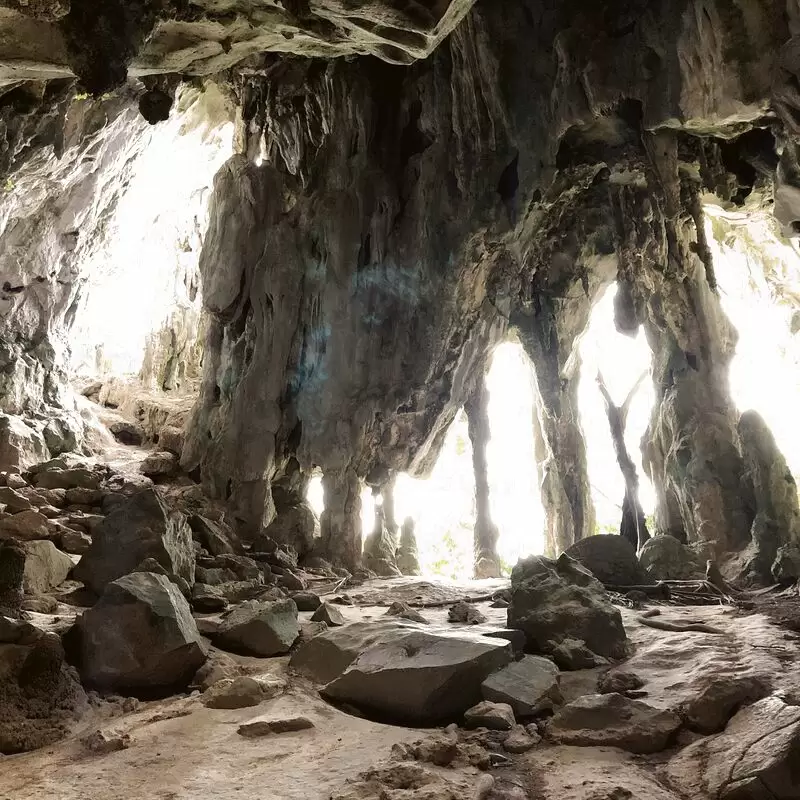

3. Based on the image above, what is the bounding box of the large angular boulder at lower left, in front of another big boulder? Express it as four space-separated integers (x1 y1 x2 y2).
78 572 206 694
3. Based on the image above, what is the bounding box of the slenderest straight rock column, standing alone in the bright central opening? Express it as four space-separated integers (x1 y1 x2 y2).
464 375 500 578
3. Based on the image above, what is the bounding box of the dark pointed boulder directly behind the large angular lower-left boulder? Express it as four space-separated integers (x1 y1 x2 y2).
75 488 195 594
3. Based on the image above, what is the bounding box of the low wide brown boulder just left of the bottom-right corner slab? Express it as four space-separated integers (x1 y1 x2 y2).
547 694 681 753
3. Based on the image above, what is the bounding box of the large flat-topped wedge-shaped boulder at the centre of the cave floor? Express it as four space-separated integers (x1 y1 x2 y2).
318 623 512 725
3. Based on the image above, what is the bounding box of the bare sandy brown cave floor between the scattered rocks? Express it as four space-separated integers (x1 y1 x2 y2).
0 579 800 800
